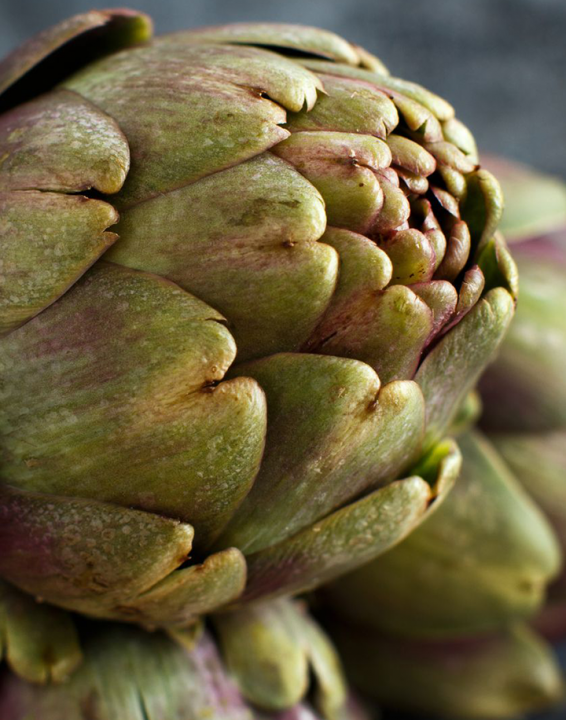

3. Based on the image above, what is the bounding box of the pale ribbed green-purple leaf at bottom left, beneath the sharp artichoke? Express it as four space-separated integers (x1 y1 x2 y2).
0 623 253 720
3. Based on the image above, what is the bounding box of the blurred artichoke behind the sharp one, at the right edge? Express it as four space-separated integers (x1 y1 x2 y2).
323 160 566 718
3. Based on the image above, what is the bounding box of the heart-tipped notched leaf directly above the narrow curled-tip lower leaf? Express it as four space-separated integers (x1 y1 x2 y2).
218 353 424 555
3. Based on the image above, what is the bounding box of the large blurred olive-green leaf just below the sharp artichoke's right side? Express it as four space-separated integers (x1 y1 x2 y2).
321 433 560 638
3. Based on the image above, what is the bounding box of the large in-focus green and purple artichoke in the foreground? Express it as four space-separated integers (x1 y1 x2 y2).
0 10 517 679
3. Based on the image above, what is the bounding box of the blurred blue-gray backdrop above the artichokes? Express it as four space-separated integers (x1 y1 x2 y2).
0 0 566 177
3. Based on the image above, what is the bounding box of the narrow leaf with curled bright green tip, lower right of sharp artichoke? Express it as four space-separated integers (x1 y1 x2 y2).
241 442 460 601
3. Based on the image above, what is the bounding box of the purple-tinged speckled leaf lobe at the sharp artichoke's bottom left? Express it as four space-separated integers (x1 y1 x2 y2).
0 485 194 617
